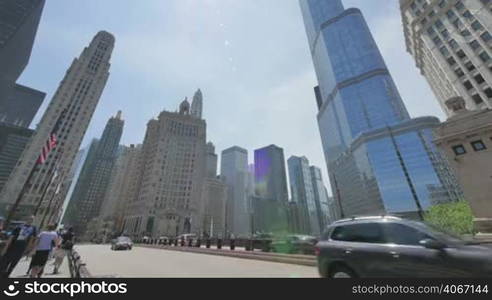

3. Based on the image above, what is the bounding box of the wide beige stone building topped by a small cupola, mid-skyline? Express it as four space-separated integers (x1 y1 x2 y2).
125 100 206 236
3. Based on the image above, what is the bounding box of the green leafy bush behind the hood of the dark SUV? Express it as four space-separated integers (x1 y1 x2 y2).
424 201 475 235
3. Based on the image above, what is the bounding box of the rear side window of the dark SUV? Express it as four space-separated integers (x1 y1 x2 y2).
331 223 384 243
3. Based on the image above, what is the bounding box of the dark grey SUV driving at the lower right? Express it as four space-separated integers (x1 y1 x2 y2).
316 217 492 278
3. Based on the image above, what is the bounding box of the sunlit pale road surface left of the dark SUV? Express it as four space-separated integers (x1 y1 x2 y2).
76 245 319 278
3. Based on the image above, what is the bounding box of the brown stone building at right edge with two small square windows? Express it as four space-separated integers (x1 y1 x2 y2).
436 97 492 233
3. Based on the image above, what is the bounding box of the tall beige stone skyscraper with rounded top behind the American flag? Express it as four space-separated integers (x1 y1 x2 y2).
0 31 115 220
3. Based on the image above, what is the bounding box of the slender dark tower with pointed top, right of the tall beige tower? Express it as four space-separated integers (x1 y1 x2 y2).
65 111 124 236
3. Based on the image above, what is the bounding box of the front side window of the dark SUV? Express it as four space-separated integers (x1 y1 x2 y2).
382 223 431 246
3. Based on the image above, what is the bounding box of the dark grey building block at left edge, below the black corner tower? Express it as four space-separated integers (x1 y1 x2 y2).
0 84 46 127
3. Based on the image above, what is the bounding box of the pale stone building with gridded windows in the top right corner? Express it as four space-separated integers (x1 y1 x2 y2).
400 0 492 116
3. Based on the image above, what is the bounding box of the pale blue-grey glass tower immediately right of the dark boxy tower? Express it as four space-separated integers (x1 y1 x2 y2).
287 156 320 235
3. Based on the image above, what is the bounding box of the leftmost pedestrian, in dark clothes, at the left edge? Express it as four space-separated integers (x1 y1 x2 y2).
0 216 37 278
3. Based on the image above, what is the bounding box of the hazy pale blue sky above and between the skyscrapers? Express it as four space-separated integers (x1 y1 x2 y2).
19 0 444 194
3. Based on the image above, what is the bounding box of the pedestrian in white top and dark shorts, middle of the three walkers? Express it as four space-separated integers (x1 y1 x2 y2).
31 224 60 278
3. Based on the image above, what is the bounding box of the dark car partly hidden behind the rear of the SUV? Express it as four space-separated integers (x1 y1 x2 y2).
271 235 318 255
